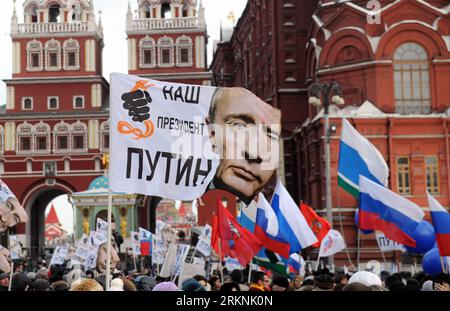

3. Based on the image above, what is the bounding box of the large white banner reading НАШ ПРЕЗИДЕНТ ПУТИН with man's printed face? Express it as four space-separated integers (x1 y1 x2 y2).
109 74 281 203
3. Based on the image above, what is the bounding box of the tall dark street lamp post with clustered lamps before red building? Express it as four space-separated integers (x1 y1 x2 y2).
309 82 345 266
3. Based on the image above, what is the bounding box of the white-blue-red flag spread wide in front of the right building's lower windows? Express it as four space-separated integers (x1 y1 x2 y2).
359 176 424 247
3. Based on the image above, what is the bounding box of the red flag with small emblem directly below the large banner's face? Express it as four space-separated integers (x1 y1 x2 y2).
211 200 261 266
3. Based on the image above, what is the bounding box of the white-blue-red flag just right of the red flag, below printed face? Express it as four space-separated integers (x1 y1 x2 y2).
255 193 290 258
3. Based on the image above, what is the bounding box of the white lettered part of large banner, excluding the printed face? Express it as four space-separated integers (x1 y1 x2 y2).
109 74 219 200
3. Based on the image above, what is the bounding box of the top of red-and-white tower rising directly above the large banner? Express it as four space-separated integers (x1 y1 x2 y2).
126 0 211 85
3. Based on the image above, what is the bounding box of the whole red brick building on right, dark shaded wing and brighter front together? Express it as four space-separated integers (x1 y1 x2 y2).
212 0 450 264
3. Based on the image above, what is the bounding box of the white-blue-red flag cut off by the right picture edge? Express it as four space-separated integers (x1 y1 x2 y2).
427 192 450 257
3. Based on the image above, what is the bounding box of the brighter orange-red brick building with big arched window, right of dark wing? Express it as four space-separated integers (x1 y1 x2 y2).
295 0 450 268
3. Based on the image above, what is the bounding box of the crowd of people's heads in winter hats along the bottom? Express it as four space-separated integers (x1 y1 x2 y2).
0 261 450 292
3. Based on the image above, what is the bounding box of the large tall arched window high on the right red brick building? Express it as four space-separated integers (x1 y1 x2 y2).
394 42 431 114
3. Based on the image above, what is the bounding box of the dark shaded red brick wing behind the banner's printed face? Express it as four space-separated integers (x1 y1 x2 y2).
211 0 317 197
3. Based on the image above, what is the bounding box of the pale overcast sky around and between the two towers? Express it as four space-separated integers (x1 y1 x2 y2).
0 0 247 105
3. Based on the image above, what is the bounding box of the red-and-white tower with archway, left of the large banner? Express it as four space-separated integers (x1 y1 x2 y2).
0 0 109 254
